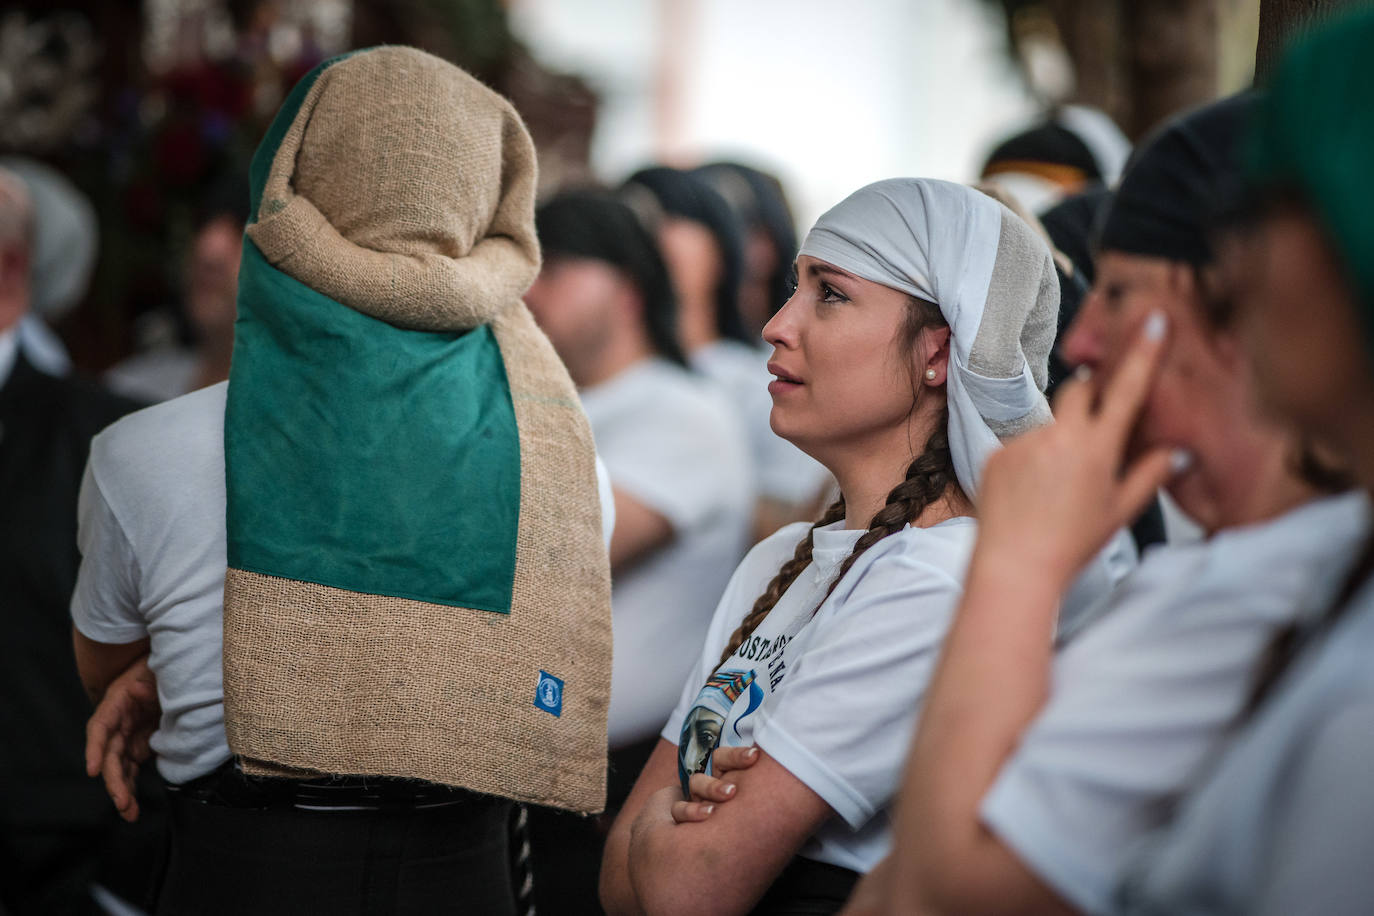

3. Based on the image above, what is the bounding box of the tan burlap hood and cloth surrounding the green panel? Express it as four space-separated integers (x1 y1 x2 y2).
224 48 611 812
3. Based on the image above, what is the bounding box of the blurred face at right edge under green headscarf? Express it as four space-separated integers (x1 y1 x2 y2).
1223 207 1374 466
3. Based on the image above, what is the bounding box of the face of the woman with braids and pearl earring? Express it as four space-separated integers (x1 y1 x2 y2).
764 255 949 464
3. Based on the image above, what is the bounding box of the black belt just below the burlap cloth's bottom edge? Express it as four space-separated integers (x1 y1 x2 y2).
166 758 503 812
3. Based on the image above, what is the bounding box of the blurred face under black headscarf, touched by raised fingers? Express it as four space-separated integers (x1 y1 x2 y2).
1061 251 1257 530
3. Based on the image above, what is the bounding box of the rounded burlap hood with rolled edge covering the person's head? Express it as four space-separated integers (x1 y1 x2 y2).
247 47 539 331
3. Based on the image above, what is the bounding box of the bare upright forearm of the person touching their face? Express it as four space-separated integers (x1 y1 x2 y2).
892 549 1063 912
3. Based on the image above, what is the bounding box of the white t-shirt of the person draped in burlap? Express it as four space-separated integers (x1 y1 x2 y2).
71 382 616 783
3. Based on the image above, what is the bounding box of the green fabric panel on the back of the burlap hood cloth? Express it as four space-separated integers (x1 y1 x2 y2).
224 240 521 614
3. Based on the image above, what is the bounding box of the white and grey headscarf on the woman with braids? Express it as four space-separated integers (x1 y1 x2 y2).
800 179 1059 499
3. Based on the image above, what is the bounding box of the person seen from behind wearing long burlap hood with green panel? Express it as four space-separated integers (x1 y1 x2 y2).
73 48 610 913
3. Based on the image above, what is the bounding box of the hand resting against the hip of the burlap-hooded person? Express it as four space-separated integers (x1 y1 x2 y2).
85 655 162 821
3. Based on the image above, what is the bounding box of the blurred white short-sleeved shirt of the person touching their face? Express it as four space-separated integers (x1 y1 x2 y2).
981 494 1369 913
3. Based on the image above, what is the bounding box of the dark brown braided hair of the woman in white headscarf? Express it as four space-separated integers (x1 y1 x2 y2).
717 297 958 665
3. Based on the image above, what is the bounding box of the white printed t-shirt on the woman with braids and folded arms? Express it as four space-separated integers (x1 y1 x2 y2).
662 518 978 873
